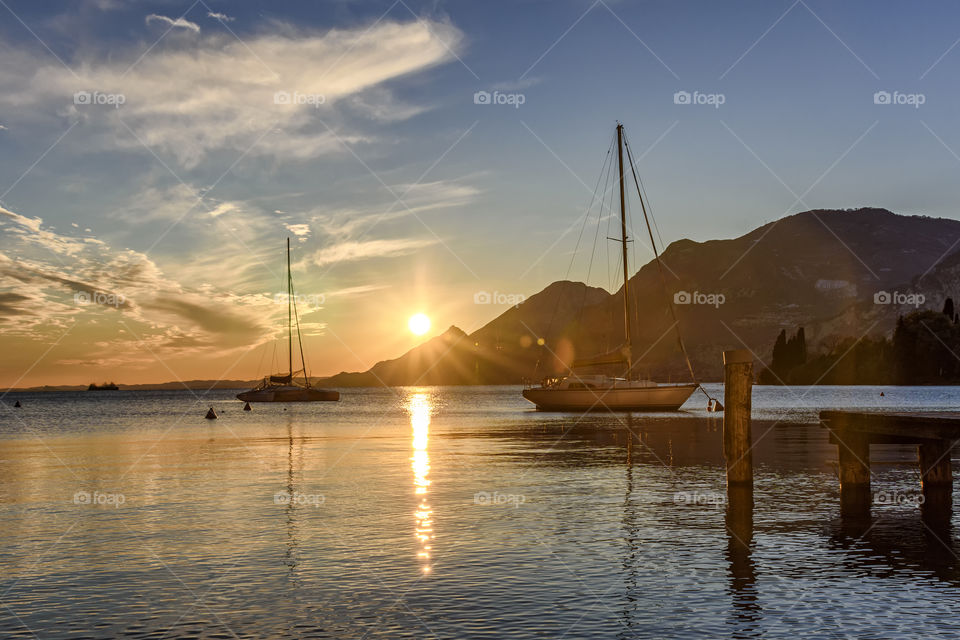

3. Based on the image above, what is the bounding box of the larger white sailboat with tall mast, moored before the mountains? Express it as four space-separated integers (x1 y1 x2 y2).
523 122 700 411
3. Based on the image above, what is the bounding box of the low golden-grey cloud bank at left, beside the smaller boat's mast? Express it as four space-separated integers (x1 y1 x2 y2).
0 202 280 353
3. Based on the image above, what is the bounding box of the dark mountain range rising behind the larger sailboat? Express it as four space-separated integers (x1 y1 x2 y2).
325 208 960 386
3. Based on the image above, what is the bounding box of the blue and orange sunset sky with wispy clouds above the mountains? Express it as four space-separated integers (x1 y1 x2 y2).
0 0 960 388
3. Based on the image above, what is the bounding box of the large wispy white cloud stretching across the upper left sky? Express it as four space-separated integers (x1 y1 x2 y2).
0 16 462 168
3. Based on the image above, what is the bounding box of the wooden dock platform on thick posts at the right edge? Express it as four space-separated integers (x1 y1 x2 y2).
820 411 960 504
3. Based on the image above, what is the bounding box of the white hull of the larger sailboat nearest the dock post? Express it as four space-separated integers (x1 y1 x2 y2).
523 384 697 411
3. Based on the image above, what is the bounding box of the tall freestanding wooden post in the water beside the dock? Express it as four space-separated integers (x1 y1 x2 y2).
723 349 753 485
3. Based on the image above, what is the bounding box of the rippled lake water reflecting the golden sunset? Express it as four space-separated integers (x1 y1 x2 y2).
0 385 960 639
